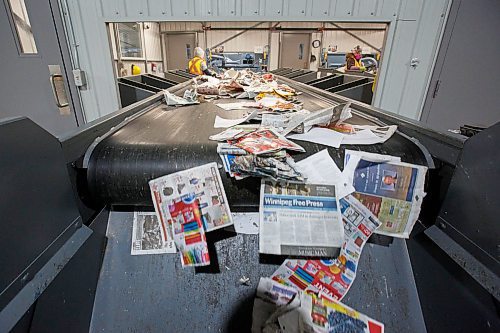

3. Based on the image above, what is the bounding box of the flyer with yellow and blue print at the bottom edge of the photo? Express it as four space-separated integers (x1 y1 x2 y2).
298 293 384 333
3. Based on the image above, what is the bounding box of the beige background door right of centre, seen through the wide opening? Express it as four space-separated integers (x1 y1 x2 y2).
280 32 311 69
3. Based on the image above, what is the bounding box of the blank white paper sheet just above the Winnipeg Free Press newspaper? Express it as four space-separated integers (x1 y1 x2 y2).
295 149 354 199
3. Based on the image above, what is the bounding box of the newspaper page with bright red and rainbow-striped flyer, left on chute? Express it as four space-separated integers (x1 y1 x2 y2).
149 163 232 266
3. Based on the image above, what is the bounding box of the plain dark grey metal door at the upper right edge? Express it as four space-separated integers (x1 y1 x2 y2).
421 0 500 131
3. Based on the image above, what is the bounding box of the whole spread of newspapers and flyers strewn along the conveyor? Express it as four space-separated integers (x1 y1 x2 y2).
136 70 427 333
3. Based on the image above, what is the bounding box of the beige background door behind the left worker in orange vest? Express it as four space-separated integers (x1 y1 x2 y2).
164 33 196 69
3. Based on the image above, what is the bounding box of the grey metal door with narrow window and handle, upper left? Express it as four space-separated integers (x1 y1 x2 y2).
0 0 83 136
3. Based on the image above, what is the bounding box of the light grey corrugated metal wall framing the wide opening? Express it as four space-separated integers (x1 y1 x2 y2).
60 0 451 120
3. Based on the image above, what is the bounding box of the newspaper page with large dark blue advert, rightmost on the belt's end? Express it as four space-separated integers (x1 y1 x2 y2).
344 154 427 238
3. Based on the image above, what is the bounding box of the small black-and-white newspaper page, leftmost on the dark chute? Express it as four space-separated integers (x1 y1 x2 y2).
131 212 176 255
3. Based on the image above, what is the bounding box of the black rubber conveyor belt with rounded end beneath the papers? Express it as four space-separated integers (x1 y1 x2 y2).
87 79 426 211
